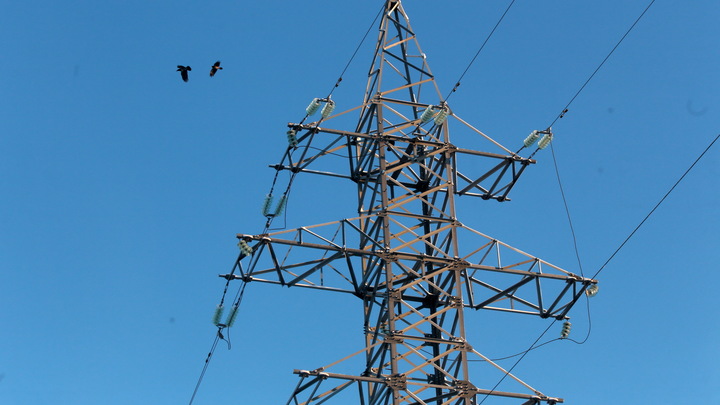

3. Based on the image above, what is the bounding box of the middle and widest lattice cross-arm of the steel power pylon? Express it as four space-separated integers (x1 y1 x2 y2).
235 216 596 319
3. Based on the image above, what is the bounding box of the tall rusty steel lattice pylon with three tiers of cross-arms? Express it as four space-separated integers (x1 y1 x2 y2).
221 0 596 405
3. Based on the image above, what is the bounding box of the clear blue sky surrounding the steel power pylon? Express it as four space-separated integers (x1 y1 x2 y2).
0 0 720 405
